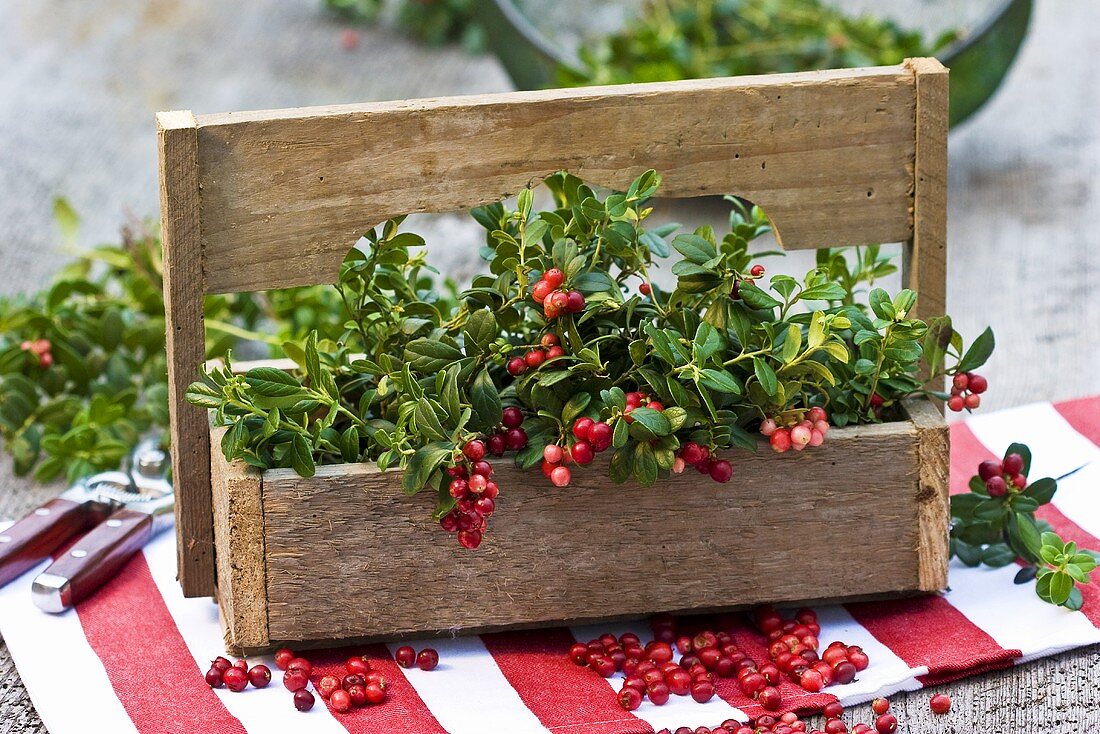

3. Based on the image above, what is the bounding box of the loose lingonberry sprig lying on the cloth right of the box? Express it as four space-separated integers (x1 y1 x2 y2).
950 443 1100 610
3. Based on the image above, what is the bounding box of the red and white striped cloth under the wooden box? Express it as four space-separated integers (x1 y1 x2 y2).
0 397 1100 734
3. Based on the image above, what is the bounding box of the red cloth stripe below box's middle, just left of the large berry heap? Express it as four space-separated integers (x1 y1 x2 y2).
481 627 653 734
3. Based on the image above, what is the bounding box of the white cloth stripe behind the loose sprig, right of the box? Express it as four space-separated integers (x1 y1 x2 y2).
967 403 1100 480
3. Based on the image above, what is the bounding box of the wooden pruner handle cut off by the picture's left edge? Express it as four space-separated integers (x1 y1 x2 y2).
0 497 91 587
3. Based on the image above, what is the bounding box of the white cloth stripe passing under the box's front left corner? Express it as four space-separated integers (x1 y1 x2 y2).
144 530 348 734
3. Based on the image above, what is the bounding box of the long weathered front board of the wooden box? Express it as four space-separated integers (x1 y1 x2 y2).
249 398 946 640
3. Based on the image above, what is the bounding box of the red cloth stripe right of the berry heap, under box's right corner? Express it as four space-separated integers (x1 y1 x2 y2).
845 596 1021 676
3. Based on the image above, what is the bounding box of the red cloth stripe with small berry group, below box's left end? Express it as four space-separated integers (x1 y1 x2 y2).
303 644 447 734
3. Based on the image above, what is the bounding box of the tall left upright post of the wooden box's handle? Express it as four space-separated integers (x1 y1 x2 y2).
156 112 215 596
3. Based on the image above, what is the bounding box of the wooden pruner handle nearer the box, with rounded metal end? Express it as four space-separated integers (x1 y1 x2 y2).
31 510 153 613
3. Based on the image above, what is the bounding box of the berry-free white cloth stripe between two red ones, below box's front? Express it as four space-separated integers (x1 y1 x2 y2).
388 635 550 734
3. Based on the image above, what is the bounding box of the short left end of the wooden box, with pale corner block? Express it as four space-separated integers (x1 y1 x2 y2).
210 428 268 655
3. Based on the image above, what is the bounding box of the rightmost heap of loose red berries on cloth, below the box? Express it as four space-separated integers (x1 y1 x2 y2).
756 606 870 695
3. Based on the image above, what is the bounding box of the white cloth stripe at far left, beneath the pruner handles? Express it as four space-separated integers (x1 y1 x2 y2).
0 523 138 734
